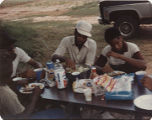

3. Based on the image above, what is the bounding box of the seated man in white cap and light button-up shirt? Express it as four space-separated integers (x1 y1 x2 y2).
52 21 97 68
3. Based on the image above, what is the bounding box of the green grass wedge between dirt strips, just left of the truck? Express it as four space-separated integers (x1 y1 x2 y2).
63 1 99 17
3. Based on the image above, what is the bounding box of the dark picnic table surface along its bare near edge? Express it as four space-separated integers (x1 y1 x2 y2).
41 79 152 118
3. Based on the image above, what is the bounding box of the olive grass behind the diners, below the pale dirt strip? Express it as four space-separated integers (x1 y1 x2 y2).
0 21 109 63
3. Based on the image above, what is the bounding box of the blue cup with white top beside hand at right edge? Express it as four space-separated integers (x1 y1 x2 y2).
135 71 146 86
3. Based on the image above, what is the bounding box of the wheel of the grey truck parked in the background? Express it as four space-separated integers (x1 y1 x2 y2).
114 16 138 38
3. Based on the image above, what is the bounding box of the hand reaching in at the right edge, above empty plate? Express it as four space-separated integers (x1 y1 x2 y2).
141 76 152 90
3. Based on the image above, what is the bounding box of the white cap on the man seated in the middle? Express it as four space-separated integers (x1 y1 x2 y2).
76 21 92 37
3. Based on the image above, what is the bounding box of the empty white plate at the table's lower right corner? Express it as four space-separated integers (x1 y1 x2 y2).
134 95 152 110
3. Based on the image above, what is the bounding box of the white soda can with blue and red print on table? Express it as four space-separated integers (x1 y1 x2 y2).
54 69 67 89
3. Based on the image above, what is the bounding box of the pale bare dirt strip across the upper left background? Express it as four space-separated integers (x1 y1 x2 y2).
0 0 98 24
